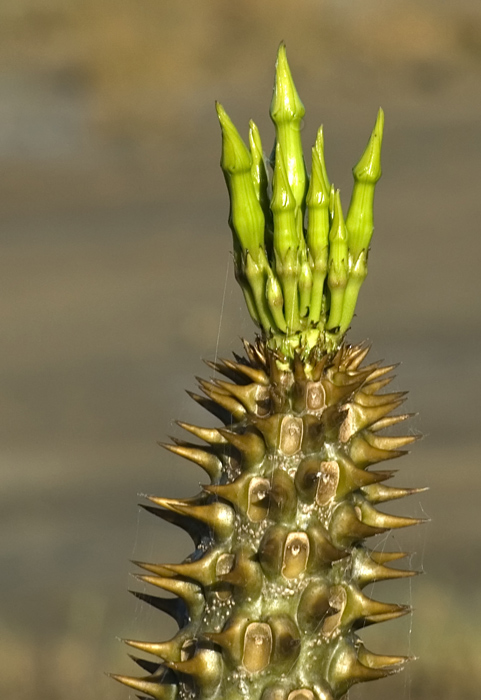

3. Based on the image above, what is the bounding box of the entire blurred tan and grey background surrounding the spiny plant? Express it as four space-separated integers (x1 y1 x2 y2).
0 0 481 700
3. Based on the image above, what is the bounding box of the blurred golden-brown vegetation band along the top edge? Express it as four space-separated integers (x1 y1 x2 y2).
0 0 481 148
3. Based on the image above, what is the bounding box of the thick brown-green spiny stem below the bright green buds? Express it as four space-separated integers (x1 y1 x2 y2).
117 340 419 700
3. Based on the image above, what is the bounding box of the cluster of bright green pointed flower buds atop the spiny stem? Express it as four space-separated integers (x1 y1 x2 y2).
217 44 384 355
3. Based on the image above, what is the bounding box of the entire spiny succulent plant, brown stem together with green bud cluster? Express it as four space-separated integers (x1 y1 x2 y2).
115 39 420 700
